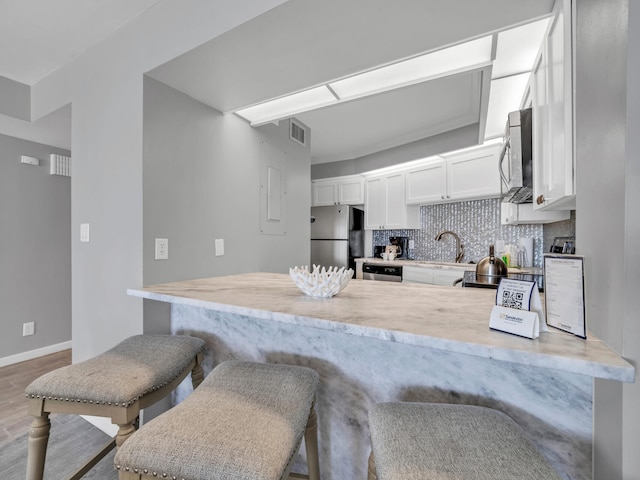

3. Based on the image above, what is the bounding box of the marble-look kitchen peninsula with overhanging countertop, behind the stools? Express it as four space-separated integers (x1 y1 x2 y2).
128 273 635 480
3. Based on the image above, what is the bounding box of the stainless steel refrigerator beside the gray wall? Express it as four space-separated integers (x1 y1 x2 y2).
310 205 364 271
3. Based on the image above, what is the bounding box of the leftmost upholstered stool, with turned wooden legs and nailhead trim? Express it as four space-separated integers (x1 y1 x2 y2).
26 335 205 480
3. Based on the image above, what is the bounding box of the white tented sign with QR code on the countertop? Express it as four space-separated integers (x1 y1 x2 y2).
489 278 548 339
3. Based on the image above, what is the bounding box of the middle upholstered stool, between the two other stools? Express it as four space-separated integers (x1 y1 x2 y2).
115 361 320 480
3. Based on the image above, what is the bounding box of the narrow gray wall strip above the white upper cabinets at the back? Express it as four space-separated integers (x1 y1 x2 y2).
311 124 478 180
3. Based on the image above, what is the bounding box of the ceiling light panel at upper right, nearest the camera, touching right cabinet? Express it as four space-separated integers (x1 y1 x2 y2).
491 18 550 78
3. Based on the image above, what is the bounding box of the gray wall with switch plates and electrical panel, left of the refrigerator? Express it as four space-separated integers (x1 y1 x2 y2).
143 78 311 285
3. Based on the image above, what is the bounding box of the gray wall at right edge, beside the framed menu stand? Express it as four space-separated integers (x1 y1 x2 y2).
575 0 640 480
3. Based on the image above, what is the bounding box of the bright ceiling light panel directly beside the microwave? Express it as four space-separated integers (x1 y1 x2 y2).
484 72 531 140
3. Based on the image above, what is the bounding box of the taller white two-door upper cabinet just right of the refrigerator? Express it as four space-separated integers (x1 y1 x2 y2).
364 171 420 230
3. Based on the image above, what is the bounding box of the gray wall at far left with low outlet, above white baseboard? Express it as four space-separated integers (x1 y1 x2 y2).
0 135 71 359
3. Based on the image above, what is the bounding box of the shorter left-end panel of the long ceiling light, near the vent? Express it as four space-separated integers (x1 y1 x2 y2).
235 85 337 126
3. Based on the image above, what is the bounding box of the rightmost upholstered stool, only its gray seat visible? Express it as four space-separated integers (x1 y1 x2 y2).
369 403 560 480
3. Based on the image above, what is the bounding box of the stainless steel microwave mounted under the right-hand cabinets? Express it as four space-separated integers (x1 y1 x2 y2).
498 108 533 203
